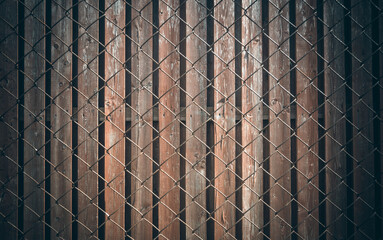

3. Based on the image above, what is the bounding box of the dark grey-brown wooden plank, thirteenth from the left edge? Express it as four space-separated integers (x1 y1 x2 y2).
323 0 347 239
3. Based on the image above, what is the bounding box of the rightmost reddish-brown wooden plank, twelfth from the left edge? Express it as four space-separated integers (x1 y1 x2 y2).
295 0 319 239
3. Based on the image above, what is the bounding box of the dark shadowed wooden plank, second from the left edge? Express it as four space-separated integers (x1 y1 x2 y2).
24 0 45 239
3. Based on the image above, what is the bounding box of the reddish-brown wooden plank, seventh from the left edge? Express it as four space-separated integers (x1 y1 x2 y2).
158 0 180 239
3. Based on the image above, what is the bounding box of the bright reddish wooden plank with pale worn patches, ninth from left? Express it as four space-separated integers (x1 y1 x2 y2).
214 0 236 239
